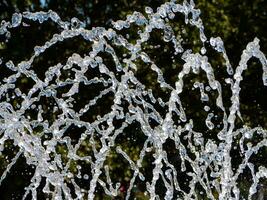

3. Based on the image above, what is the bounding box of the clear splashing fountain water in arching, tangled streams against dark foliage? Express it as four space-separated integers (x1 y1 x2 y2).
0 0 267 200
